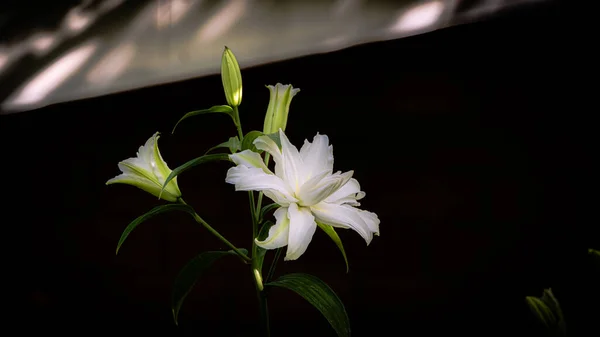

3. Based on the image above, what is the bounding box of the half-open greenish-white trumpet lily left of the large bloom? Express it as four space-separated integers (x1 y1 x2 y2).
106 132 181 202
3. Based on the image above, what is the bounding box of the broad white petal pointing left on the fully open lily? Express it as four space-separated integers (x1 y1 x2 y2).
225 165 298 206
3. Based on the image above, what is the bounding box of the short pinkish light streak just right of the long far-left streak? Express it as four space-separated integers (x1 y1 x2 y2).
86 43 137 85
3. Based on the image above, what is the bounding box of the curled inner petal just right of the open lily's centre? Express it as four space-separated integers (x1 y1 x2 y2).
296 171 354 206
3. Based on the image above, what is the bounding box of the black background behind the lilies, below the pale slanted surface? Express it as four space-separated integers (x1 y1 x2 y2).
0 4 599 336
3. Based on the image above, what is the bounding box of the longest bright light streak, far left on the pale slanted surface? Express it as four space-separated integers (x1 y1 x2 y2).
7 43 98 105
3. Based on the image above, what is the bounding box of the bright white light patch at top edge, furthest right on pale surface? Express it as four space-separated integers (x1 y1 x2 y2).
390 1 444 33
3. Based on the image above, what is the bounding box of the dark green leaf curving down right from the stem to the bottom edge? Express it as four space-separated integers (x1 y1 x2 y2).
265 273 350 337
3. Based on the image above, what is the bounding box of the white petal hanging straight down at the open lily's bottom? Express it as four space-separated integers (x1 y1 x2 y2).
284 204 317 261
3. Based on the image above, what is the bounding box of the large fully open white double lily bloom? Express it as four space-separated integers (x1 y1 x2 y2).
225 129 379 261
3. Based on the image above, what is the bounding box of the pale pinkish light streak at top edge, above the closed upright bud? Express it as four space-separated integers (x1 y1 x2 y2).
196 0 248 42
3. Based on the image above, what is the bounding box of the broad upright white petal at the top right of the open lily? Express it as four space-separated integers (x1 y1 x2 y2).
300 133 333 182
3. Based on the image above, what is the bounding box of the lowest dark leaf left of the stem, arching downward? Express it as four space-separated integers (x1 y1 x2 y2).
171 249 248 324
